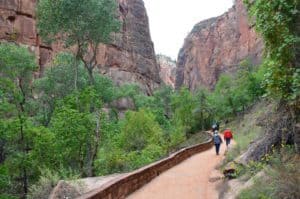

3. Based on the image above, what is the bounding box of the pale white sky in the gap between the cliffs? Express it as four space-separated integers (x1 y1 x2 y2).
144 0 233 60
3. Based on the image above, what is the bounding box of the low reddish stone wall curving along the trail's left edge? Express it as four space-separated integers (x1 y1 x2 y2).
78 139 213 199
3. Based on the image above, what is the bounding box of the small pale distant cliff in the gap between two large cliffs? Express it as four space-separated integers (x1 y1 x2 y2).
156 55 176 88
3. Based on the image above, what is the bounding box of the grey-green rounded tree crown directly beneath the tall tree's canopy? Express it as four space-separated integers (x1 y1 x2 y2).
34 53 88 126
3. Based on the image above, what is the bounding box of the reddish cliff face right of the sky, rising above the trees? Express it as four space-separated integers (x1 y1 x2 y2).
176 0 263 90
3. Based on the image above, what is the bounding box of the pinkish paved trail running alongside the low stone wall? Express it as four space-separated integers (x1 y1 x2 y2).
127 138 230 199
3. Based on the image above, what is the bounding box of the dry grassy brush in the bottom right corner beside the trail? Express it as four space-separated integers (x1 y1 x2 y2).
238 146 300 199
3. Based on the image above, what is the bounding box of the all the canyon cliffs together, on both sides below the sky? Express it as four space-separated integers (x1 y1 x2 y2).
0 0 263 91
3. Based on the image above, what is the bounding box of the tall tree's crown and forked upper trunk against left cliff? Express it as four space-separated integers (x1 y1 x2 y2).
37 0 120 84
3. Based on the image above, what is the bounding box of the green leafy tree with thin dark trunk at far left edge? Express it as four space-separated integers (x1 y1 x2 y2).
0 43 37 198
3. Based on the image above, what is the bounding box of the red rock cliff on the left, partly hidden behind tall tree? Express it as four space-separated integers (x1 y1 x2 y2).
0 0 160 93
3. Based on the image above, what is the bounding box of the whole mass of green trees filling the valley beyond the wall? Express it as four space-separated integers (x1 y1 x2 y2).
0 43 263 198
